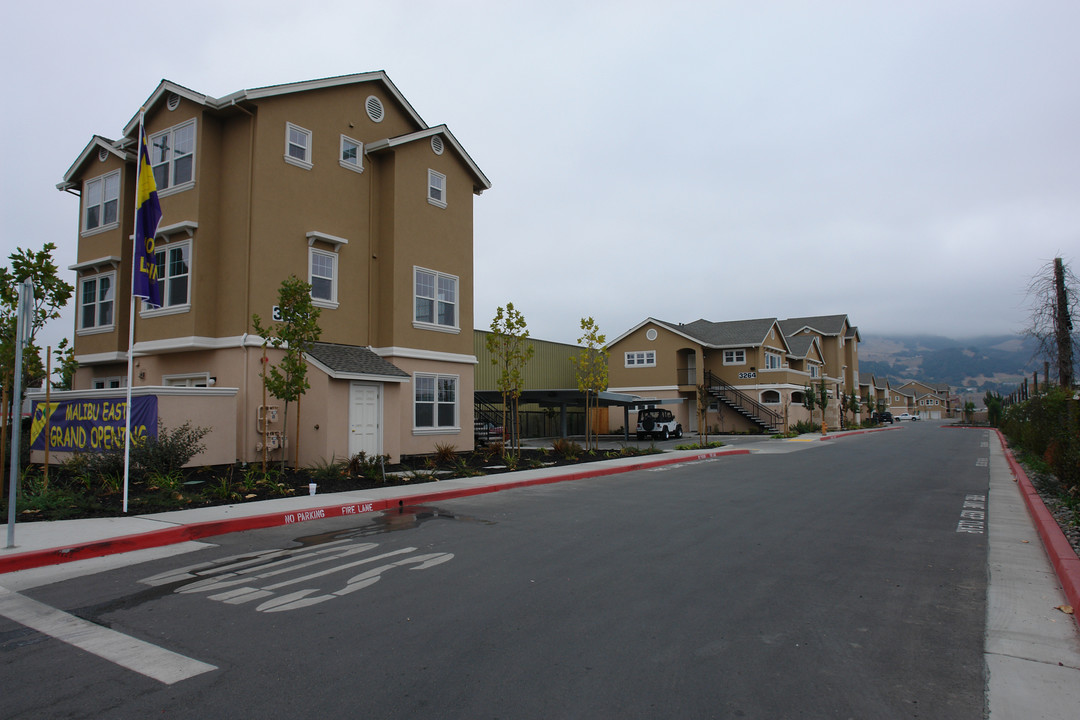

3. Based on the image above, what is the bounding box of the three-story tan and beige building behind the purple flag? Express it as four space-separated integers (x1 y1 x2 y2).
57 72 491 465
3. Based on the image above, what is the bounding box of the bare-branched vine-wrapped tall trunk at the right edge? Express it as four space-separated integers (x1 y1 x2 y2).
1027 258 1080 388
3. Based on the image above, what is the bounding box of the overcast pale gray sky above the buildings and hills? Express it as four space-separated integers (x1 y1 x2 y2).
0 0 1080 342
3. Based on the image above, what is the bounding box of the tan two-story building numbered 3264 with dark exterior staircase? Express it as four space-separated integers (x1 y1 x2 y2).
608 314 860 432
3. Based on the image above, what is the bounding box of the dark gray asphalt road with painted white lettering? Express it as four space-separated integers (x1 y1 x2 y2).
0 422 988 719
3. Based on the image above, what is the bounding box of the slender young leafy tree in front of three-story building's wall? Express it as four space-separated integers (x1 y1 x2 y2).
252 275 323 472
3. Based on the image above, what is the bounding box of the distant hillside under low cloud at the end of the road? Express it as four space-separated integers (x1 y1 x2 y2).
859 335 1042 397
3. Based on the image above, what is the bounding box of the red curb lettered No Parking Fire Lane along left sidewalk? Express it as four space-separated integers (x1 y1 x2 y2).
0 450 750 574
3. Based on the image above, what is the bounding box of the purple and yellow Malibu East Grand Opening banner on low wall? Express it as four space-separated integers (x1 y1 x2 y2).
30 395 158 452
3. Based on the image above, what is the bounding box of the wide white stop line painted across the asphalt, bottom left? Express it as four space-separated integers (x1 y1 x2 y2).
0 587 217 685
